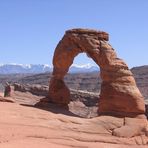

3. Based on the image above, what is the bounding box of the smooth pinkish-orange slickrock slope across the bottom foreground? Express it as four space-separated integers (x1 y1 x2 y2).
0 102 148 148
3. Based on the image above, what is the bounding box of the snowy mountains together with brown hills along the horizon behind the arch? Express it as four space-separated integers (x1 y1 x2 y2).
0 64 148 100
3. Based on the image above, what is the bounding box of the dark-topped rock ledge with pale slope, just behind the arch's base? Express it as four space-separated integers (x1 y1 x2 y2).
0 83 148 118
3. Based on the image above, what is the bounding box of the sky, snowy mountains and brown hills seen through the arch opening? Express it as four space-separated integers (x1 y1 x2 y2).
64 53 101 93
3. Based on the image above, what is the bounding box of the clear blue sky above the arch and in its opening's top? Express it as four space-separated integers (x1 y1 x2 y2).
0 0 148 67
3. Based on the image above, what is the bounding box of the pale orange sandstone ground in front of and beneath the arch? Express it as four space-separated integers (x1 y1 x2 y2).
0 86 148 148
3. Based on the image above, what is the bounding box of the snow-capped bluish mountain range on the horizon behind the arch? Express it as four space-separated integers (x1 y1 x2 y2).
0 63 99 74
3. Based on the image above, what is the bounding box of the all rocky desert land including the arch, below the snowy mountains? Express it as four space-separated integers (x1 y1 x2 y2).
0 29 148 148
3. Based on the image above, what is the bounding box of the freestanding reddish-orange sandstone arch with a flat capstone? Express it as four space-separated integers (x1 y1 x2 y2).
49 29 145 117
